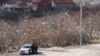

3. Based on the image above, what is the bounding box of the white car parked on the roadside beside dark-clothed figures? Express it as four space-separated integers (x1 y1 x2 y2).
19 44 33 55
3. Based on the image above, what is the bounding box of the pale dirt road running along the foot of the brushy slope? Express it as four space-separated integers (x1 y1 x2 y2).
0 44 100 56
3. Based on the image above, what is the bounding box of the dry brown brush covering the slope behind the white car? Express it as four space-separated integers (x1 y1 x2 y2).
0 9 100 52
